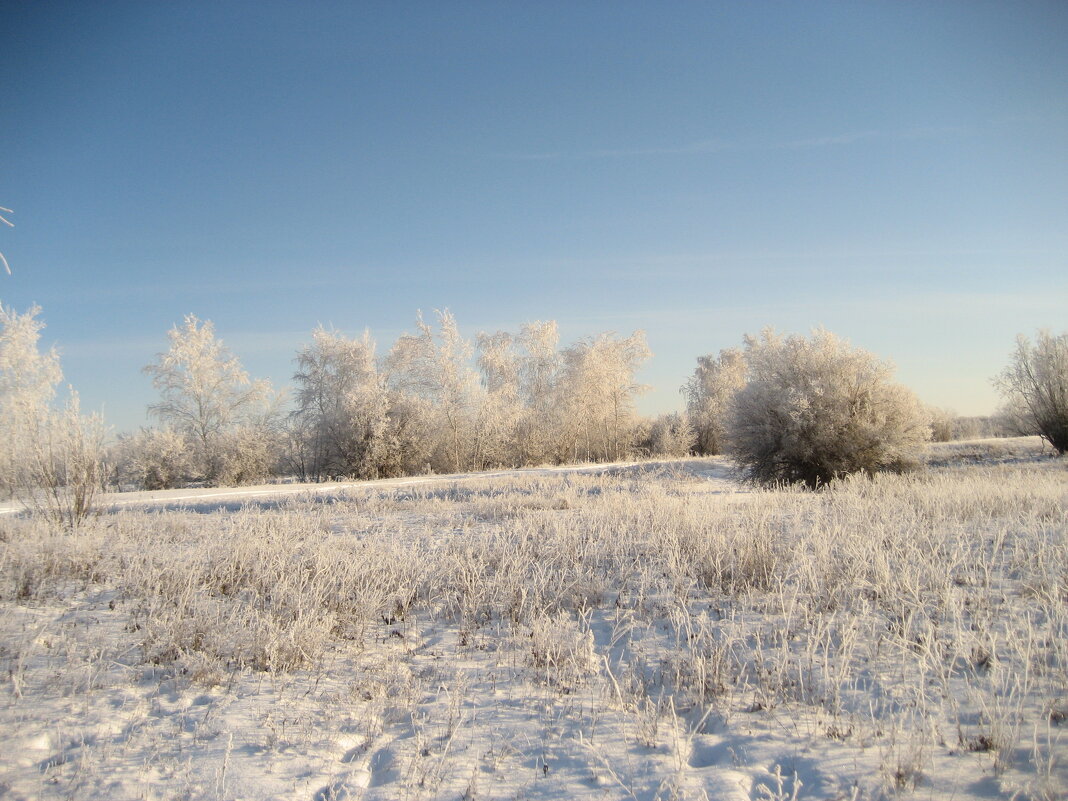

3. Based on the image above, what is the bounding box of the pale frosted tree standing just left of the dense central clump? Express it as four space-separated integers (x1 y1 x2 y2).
144 314 279 485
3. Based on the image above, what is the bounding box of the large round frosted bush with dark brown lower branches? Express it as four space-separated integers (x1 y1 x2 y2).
727 329 930 487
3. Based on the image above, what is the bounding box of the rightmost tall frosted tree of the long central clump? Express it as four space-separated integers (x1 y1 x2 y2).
557 331 650 461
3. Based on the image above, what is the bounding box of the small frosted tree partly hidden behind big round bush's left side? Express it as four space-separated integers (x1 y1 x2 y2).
682 348 745 456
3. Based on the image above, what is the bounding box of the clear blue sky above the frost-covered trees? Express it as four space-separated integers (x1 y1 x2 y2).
0 0 1068 429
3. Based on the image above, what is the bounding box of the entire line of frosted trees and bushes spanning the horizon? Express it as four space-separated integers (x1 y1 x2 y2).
0 294 1068 524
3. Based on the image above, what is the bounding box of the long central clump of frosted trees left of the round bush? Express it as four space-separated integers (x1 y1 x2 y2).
120 311 649 487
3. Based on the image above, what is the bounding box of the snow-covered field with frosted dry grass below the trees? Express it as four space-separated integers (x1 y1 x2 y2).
0 441 1068 801
